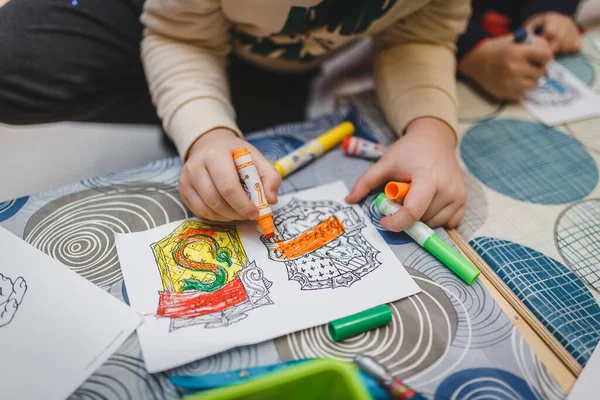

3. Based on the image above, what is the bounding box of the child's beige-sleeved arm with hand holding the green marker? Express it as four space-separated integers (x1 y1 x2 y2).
348 0 470 231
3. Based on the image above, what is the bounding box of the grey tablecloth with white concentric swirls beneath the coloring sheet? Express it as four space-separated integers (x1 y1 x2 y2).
0 108 564 399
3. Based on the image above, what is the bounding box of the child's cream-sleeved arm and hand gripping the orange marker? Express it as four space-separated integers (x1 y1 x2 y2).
141 0 281 221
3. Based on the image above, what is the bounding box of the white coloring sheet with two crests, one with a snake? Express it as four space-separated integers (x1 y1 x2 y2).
116 182 421 372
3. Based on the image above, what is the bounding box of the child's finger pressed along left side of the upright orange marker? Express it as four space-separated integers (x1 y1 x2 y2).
206 156 258 219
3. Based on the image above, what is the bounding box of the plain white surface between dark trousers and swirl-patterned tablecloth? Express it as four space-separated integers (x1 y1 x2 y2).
0 122 175 202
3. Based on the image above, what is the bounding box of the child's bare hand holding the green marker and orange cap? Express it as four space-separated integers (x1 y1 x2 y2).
346 118 467 232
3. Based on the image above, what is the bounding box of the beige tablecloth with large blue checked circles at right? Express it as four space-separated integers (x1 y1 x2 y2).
350 43 600 372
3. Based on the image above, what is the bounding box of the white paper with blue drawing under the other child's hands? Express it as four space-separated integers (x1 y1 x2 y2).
523 61 600 126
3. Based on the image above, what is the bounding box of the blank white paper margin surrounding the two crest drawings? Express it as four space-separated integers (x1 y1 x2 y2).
115 182 421 373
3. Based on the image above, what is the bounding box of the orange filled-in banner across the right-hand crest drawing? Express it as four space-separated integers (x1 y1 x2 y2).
274 216 345 260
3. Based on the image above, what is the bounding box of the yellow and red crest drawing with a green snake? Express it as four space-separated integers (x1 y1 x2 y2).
151 220 272 330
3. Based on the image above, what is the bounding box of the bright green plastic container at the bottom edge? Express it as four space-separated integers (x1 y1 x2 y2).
183 360 372 400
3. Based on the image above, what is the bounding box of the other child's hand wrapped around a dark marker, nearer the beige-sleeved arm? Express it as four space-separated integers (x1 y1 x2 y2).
458 35 552 100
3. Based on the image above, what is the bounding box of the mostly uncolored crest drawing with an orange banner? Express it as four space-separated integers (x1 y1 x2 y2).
261 198 381 290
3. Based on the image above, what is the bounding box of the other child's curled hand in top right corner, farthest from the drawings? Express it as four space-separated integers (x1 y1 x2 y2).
523 12 581 54
